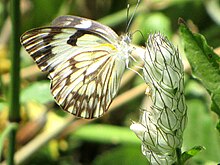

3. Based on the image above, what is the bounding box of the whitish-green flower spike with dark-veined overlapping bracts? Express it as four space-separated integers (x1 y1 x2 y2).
130 33 187 165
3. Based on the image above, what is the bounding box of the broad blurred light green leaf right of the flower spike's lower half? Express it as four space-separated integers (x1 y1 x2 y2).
182 98 220 164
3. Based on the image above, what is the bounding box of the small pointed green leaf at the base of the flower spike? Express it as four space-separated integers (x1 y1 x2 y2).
181 146 205 164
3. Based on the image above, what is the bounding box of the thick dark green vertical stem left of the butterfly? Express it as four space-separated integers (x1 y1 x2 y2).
7 0 20 165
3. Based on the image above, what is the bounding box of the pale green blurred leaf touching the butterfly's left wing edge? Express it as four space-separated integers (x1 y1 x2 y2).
21 81 54 104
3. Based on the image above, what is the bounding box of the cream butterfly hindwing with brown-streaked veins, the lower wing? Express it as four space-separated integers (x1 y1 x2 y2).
51 49 123 118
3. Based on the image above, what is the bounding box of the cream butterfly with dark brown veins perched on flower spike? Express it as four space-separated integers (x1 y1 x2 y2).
20 15 133 119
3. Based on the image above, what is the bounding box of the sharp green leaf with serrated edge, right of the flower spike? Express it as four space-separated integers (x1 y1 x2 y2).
180 24 220 115
